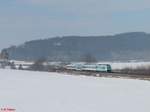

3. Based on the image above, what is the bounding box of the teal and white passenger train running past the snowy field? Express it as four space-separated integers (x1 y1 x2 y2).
66 63 112 72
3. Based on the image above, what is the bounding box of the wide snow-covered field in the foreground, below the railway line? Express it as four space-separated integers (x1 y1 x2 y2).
0 69 150 112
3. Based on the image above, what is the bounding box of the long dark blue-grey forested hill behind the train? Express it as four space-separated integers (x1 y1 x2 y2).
3 32 150 61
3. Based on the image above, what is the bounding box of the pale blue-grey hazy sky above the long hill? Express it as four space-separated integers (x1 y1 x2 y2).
0 0 150 49
